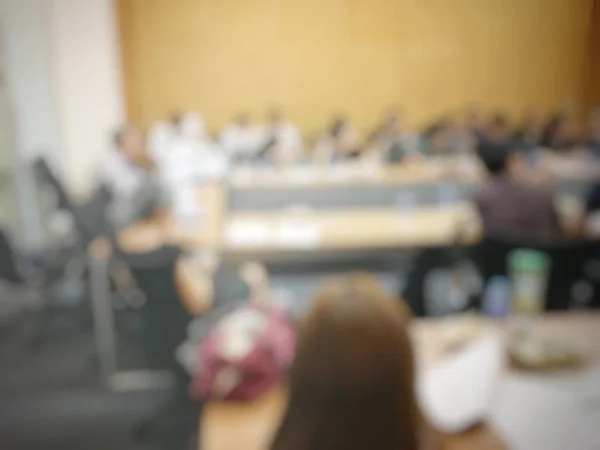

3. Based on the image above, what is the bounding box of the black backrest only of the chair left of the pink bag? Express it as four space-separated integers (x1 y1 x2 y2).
119 247 191 370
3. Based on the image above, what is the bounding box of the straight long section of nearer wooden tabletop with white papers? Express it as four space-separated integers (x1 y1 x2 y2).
223 204 480 253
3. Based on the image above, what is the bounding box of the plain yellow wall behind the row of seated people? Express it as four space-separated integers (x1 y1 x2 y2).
118 0 592 134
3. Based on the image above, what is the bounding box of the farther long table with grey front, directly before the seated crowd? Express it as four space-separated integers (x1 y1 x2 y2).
227 155 600 212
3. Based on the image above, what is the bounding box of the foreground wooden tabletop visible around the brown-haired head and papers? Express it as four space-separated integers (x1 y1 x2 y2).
200 313 600 450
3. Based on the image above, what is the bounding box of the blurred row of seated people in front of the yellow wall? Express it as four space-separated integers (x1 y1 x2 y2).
106 103 600 185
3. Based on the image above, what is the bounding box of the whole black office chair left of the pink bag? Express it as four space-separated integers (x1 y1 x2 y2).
118 247 200 450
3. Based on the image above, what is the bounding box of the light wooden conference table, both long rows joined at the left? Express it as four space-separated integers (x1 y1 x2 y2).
121 155 600 257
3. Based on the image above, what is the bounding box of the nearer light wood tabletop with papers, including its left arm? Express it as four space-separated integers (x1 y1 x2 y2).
119 195 579 259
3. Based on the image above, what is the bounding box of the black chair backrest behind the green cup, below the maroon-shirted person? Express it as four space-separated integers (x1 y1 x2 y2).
473 235 594 310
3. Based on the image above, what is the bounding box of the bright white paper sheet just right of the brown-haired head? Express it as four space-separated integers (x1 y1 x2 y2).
418 332 505 433
